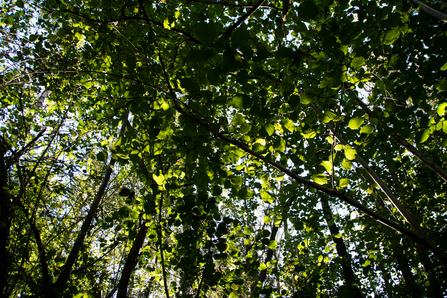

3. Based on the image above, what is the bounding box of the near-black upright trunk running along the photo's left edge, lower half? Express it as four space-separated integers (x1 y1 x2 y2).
0 143 11 296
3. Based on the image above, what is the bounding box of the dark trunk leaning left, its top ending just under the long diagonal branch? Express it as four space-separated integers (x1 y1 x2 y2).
320 196 363 298
